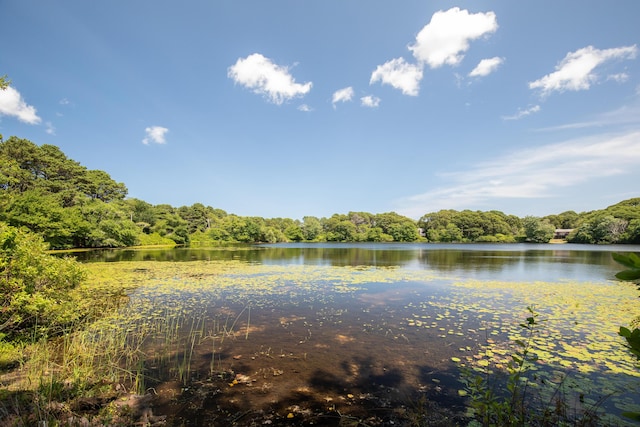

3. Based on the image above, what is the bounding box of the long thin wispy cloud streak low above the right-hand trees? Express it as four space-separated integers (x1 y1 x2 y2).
398 131 640 218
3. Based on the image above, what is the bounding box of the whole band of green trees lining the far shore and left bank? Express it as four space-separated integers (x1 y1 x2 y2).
0 135 640 249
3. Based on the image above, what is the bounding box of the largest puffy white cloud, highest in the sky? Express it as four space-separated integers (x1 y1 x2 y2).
409 7 498 68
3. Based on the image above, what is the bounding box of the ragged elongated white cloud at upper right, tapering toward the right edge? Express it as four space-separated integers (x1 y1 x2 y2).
529 45 638 96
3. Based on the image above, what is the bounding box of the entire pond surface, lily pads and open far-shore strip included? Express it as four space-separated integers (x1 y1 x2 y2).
71 244 640 425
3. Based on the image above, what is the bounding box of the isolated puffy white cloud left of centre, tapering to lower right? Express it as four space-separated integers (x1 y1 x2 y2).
227 53 313 105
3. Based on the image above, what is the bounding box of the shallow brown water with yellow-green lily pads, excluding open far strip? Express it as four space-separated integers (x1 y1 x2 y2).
82 261 640 425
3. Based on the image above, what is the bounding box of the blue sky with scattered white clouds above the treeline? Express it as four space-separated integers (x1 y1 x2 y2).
0 0 640 219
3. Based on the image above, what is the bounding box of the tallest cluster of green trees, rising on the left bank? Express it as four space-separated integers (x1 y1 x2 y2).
0 137 134 248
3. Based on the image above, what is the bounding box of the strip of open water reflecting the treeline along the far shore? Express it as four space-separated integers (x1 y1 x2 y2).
61 243 640 280
